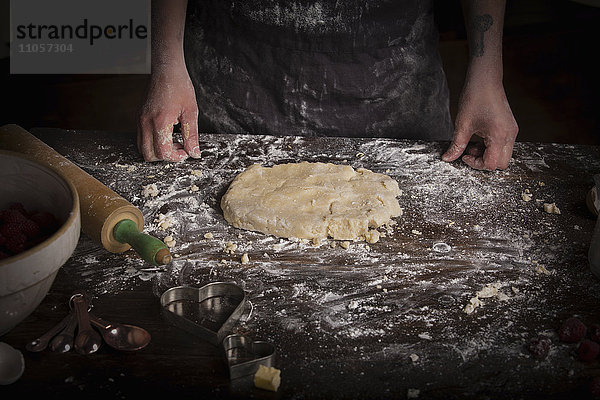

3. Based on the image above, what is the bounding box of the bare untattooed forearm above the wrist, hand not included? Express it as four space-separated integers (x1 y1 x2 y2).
152 0 187 69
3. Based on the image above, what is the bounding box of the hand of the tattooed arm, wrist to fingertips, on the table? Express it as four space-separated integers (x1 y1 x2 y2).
442 81 519 171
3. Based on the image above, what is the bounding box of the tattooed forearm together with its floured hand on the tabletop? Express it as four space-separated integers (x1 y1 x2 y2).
442 0 519 171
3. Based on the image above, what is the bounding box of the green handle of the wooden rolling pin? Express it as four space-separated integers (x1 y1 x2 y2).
113 219 172 266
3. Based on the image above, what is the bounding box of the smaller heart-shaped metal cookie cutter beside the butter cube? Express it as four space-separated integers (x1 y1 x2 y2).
223 334 275 379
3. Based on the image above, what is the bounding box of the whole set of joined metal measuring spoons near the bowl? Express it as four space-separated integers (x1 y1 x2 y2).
25 292 150 354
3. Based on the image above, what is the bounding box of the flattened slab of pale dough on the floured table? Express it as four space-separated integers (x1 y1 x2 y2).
221 162 402 242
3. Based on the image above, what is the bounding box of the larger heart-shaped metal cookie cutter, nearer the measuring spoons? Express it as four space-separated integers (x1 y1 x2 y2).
160 282 246 346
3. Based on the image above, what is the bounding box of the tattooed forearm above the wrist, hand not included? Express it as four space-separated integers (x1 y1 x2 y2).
462 0 506 86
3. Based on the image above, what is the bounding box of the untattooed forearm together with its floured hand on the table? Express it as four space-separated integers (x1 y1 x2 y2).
137 0 200 161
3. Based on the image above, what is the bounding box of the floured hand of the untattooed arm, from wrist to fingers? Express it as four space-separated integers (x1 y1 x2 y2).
137 64 200 161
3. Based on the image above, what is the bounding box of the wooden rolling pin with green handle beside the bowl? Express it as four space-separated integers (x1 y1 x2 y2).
0 125 171 265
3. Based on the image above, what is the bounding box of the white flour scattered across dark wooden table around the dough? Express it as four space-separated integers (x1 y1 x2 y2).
58 135 600 396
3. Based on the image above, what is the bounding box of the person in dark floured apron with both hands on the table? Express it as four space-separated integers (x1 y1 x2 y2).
138 0 518 170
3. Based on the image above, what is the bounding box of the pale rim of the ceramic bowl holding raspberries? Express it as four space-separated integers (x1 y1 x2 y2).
0 150 79 268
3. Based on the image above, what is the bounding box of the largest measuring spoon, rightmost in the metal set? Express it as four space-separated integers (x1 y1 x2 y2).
90 314 150 351
